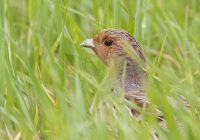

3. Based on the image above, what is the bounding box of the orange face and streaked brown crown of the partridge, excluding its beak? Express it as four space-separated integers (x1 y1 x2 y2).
93 29 145 64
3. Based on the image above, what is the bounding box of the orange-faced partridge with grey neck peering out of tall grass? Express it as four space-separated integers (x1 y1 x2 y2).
80 28 147 115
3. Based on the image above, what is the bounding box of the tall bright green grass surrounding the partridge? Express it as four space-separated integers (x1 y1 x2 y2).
0 0 200 140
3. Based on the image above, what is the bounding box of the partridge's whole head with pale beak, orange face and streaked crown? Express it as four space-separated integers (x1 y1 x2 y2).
80 29 145 65
